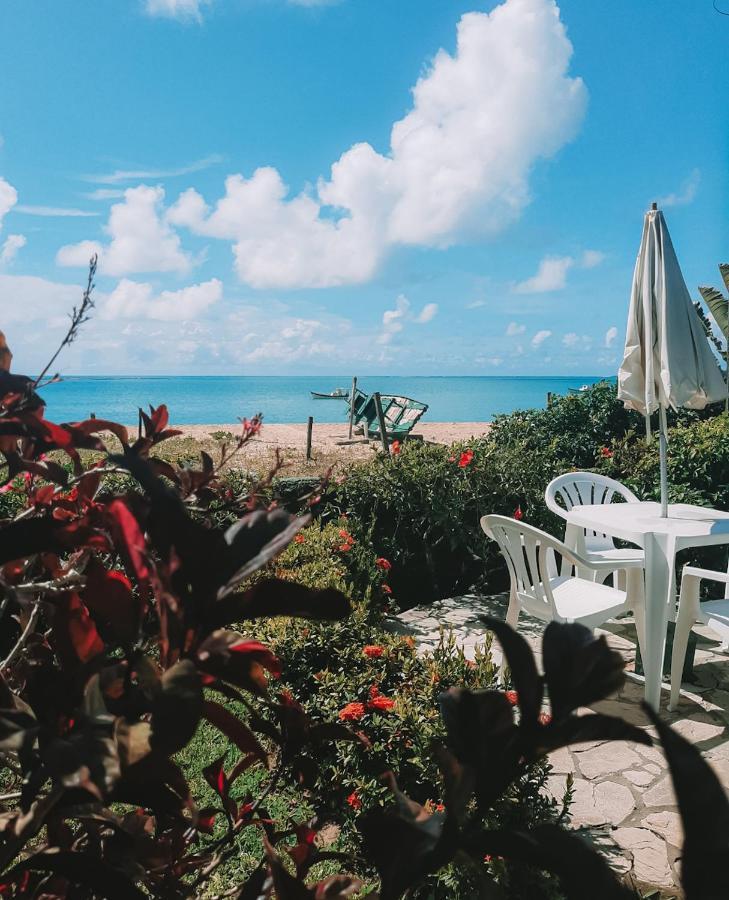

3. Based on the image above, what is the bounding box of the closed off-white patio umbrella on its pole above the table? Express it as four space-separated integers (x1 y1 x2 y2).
618 203 726 517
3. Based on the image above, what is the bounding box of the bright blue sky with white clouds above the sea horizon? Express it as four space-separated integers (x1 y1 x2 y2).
0 0 729 375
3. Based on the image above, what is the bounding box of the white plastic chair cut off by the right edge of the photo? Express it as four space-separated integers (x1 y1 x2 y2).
668 566 729 709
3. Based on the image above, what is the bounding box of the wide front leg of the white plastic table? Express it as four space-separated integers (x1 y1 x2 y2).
643 534 676 711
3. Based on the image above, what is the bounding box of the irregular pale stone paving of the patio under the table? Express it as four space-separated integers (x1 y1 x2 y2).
391 594 729 896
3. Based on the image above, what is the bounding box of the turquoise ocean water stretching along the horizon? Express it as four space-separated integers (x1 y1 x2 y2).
38 375 600 425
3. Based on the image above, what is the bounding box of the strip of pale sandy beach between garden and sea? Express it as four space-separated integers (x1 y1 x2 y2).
163 422 491 474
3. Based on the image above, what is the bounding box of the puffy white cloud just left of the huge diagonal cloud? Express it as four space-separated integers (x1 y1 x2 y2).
56 185 192 275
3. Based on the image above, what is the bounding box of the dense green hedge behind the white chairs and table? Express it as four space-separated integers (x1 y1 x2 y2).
325 382 729 607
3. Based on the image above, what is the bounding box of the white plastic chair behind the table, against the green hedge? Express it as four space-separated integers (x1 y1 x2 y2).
544 472 645 587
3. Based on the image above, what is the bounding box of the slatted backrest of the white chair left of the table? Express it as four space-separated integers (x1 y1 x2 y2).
481 515 569 617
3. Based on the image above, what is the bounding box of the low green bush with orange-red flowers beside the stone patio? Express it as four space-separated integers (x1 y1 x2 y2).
230 519 563 900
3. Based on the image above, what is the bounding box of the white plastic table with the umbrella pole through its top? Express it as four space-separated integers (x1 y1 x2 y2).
565 502 729 710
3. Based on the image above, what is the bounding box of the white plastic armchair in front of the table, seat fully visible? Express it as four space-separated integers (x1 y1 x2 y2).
481 515 645 672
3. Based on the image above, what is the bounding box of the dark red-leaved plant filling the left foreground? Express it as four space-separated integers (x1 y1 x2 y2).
0 322 360 898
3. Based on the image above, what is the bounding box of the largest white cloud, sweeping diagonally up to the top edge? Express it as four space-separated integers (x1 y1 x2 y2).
169 0 587 288
